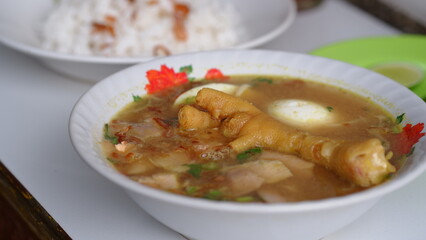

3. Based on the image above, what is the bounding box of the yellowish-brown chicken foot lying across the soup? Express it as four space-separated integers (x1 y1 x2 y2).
179 88 395 187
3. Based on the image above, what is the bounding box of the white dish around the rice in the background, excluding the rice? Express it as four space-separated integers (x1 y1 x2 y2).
0 0 296 81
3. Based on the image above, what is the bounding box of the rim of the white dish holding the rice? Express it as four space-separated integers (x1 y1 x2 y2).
0 0 297 64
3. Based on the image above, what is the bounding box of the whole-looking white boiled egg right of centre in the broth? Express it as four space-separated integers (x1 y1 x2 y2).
268 99 333 128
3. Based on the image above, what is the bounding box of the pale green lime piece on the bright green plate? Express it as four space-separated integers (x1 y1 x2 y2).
370 63 423 87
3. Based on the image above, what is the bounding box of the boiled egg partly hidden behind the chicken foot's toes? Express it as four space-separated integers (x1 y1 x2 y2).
174 83 238 106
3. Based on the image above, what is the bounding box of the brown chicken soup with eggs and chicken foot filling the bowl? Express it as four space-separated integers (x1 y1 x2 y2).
101 66 424 203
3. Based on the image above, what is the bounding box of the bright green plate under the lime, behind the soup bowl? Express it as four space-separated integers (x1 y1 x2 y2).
310 34 426 99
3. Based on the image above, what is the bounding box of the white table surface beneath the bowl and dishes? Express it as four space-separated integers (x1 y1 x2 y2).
0 0 426 240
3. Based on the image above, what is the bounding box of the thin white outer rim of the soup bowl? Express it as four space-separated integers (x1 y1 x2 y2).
68 50 426 214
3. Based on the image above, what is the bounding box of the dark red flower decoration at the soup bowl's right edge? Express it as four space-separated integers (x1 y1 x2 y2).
393 123 425 154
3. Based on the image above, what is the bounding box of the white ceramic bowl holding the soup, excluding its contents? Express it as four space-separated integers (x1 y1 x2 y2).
69 50 426 240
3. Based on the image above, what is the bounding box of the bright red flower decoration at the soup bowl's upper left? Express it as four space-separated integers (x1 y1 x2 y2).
145 65 188 94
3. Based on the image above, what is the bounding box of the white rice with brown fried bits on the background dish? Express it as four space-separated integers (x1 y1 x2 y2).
41 0 240 57
